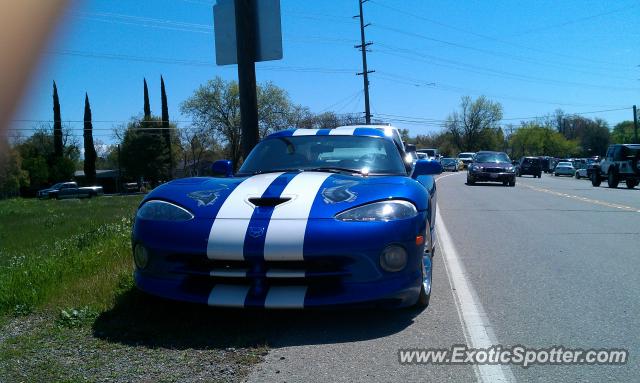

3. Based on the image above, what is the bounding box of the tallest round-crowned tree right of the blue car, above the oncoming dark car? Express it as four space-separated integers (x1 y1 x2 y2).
445 96 502 151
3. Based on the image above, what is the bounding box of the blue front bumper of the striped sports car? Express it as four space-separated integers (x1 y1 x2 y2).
133 216 427 309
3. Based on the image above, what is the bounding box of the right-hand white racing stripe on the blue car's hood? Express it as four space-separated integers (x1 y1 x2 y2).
264 173 331 261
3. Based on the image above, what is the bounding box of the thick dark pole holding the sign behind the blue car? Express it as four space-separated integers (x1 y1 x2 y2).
234 0 259 159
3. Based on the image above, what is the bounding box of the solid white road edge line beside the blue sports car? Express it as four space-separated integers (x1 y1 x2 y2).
436 208 515 382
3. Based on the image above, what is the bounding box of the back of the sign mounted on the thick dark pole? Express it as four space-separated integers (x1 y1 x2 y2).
213 0 282 65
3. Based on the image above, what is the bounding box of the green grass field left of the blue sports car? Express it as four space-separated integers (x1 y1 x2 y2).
0 196 141 316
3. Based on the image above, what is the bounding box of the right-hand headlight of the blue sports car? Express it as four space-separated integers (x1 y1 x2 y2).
336 200 418 222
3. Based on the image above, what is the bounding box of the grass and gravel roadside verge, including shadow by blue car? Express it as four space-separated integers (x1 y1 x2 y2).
0 196 266 382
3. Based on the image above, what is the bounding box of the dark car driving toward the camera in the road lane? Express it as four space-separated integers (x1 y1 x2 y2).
467 151 516 186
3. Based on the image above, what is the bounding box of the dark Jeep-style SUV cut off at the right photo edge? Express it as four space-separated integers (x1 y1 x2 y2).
587 144 640 189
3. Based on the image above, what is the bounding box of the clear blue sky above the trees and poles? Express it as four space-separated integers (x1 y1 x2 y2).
12 0 640 147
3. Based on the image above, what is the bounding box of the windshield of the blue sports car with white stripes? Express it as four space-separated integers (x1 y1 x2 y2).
239 136 406 175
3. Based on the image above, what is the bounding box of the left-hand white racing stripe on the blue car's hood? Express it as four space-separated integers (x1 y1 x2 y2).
207 173 283 261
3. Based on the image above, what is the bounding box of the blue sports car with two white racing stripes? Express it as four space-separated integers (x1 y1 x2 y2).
132 126 442 308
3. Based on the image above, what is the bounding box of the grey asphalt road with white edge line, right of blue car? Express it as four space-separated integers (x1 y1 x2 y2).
249 172 640 382
